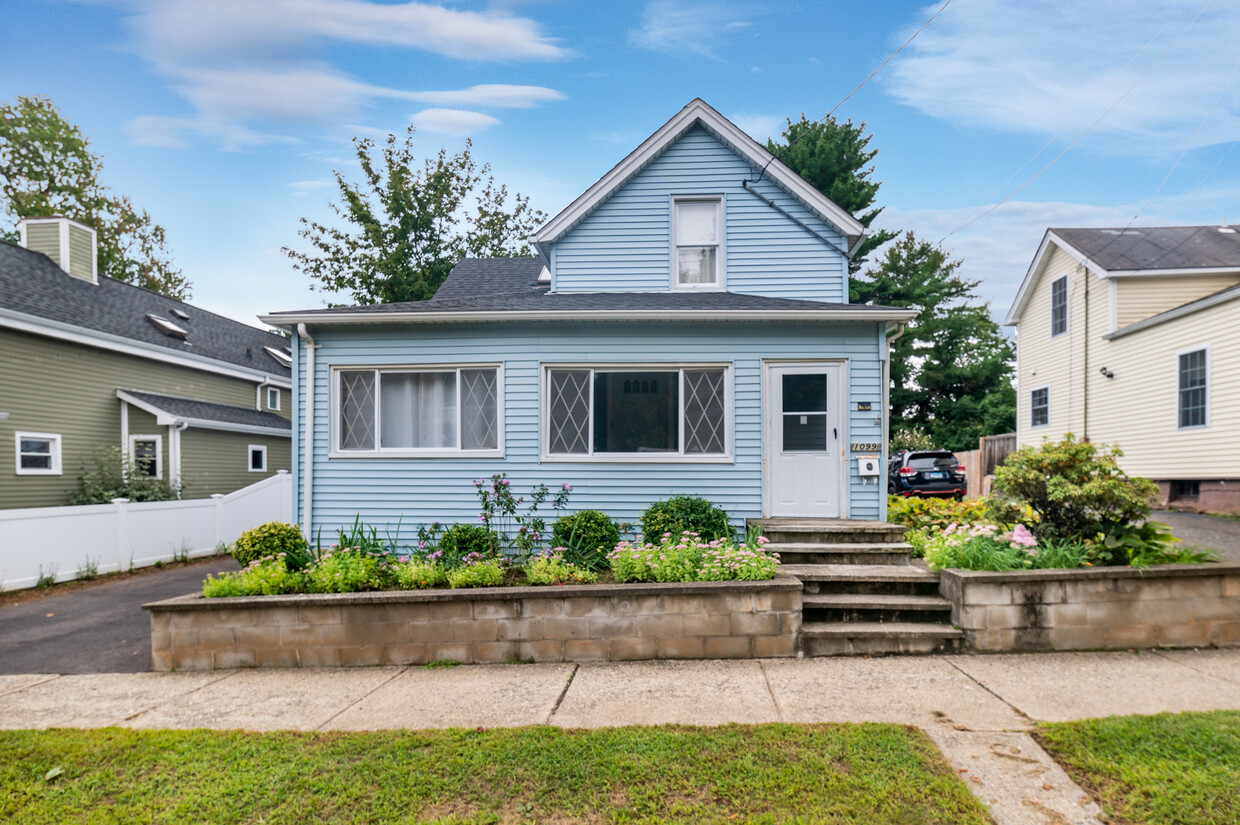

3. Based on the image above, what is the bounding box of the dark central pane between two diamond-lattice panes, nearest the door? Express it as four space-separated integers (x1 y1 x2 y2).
594 372 680 453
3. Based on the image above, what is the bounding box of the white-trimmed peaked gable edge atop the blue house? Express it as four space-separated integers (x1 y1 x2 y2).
533 98 866 257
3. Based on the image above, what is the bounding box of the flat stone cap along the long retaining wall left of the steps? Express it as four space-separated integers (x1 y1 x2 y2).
143 574 801 612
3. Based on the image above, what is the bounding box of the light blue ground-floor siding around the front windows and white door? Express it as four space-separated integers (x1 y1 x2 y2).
294 321 882 541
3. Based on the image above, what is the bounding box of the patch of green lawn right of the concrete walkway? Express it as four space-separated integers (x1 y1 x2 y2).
1038 711 1240 825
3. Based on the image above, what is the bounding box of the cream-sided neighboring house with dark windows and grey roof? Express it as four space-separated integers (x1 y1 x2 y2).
1006 226 1240 512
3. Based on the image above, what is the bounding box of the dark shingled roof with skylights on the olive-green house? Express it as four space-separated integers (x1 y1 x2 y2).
0 242 291 383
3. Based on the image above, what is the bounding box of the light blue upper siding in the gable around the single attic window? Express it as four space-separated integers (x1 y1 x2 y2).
552 128 848 303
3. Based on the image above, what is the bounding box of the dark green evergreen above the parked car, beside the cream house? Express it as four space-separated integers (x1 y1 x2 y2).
852 232 1016 450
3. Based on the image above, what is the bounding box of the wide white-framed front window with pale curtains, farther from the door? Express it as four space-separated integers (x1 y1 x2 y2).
336 366 501 455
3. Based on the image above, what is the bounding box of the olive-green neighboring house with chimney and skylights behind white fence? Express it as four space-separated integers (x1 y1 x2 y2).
0 217 291 509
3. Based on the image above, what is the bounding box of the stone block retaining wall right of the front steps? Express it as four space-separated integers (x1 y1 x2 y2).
939 562 1240 651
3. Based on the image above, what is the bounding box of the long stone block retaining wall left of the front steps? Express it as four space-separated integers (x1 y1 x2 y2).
143 576 801 670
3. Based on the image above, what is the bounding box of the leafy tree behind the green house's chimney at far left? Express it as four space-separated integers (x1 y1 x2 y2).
0 96 190 298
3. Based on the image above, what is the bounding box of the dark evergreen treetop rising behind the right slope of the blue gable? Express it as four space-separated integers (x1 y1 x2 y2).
766 114 897 273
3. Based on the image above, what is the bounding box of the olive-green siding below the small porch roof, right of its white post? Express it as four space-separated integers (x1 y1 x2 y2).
181 429 289 499
